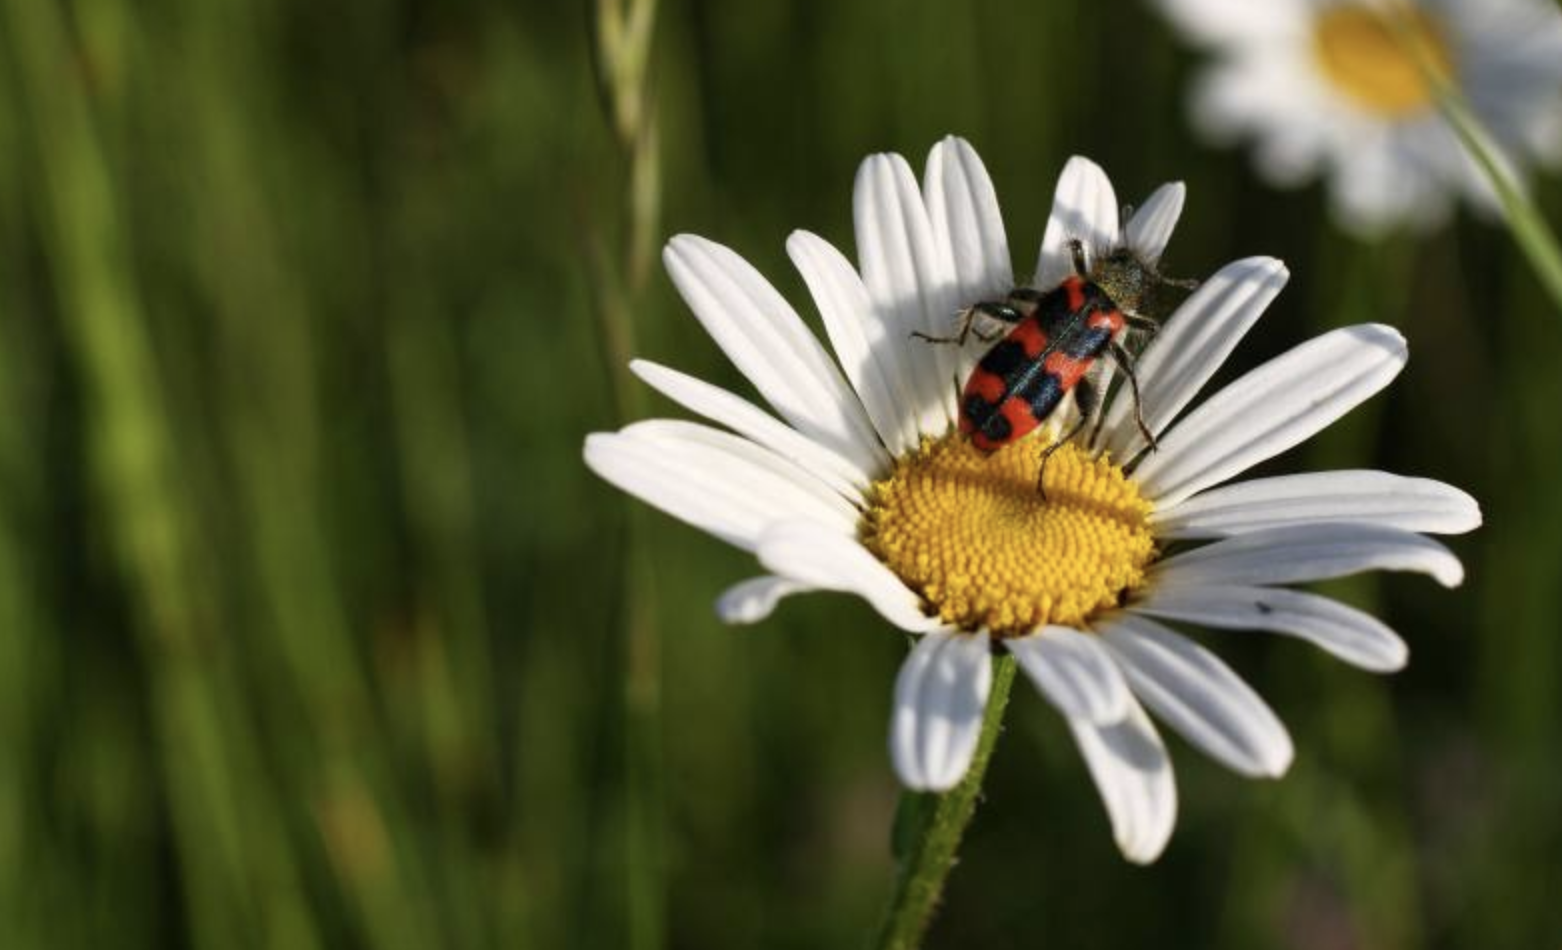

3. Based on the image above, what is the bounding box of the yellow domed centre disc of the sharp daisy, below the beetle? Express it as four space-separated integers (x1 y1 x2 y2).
862 434 1156 636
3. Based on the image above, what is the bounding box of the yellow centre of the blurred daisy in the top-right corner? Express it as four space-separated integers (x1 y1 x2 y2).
1312 3 1453 119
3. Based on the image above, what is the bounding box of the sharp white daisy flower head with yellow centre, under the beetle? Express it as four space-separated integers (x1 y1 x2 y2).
586 138 1479 863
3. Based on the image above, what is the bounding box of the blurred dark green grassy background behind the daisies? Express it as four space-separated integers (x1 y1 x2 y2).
0 0 1562 948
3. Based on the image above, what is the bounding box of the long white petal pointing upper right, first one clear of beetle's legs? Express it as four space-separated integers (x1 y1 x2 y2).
1134 323 1406 508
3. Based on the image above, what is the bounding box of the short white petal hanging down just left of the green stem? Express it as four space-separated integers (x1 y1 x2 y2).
889 631 992 792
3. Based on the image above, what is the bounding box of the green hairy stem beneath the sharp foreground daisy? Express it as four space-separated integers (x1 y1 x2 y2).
873 655 1015 950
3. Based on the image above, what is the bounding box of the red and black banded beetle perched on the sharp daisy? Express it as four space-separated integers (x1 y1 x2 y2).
915 241 1193 498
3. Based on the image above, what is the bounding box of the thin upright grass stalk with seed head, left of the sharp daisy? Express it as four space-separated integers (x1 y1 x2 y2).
592 0 665 950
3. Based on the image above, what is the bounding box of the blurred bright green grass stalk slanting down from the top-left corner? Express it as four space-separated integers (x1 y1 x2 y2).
0 3 319 948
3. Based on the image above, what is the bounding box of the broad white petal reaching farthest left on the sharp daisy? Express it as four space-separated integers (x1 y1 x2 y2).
586 420 856 550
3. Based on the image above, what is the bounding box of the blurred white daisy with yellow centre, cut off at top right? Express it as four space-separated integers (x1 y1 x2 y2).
1159 0 1562 234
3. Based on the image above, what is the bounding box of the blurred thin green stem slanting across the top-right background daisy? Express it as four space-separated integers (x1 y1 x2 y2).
1382 11 1562 314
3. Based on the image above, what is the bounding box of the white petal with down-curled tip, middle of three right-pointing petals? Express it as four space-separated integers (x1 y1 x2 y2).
1153 523 1464 588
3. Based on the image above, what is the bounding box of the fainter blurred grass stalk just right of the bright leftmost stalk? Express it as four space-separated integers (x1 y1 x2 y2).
172 0 440 950
